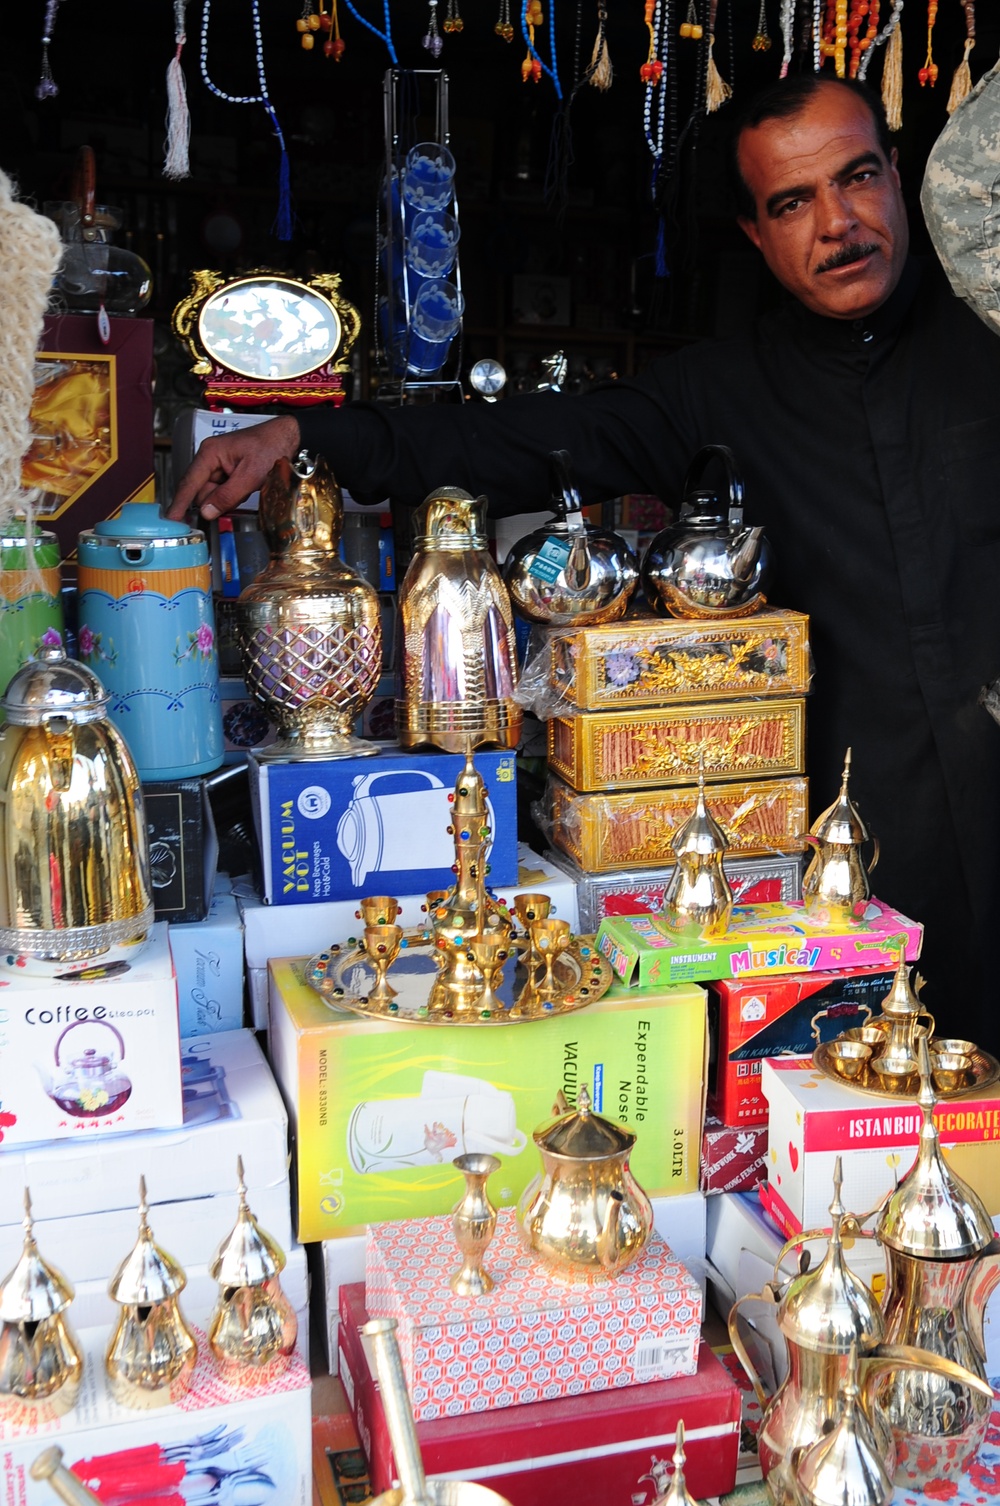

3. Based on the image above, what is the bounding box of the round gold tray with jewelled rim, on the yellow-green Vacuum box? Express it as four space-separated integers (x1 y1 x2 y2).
306 931 614 1026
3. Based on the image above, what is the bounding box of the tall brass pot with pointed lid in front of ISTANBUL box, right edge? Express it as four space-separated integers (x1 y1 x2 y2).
875 1036 1000 1492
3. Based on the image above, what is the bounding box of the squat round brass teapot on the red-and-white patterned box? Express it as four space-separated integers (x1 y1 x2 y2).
518 1087 652 1280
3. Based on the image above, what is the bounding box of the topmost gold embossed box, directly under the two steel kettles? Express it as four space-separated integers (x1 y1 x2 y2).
548 610 812 711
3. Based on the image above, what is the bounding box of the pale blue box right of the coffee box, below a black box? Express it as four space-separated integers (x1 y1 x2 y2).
170 890 242 1041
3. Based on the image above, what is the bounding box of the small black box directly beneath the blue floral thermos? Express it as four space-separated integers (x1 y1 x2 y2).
143 779 218 922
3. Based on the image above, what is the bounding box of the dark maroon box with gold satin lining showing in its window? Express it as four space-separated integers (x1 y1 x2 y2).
21 313 154 560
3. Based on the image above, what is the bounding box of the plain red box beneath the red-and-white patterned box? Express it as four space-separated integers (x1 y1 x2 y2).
340 1282 739 1506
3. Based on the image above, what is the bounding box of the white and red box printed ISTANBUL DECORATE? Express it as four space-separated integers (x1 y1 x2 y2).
761 1057 1000 1233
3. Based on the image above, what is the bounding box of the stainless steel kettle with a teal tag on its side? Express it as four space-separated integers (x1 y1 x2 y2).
503 450 639 626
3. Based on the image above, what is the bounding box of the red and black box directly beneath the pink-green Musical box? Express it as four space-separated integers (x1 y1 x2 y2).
706 967 893 1126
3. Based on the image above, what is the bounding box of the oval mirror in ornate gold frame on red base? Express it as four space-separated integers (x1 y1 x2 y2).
172 268 361 408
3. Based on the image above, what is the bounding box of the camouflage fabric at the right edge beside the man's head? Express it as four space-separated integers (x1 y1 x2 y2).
920 63 1000 334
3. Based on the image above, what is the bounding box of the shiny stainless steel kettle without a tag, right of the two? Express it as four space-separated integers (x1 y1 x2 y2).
642 444 771 617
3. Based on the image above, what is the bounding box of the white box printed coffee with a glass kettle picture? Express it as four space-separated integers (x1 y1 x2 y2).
0 922 184 1151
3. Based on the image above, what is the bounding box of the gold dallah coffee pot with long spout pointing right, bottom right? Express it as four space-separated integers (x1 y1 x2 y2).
729 1157 992 1506
